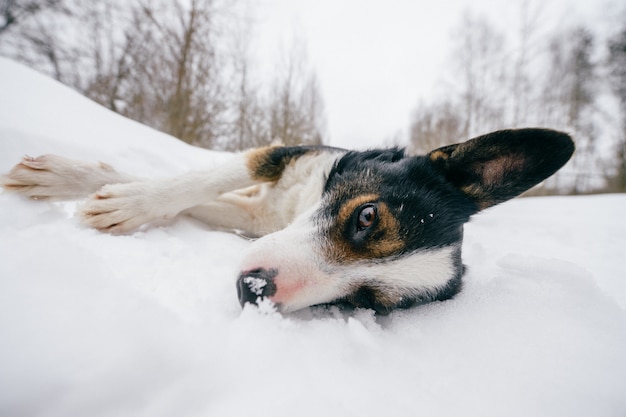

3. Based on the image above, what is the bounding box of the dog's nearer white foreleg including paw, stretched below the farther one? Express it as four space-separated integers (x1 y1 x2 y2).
79 154 262 233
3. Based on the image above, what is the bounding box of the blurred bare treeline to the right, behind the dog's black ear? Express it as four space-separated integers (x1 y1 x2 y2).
410 8 626 193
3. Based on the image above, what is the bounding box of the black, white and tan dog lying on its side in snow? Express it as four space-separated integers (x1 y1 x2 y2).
0 128 574 314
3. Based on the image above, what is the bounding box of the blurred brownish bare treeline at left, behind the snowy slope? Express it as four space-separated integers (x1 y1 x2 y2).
0 0 325 150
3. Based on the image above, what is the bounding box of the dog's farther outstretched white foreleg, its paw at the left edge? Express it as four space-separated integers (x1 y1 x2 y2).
0 155 137 201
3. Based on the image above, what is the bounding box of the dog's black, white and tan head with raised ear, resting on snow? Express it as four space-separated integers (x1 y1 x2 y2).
237 129 574 313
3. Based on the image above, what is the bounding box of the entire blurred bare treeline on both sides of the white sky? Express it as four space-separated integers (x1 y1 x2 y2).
0 0 626 193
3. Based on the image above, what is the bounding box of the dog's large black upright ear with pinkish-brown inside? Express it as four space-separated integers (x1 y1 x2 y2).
428 129 574 210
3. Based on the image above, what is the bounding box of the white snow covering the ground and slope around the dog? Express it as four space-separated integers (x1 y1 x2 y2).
0 59 626 417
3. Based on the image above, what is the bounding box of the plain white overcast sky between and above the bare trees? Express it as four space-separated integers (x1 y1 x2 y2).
249 0 624 148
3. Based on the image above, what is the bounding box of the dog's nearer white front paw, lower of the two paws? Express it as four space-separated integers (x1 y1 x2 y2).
78 182 176 234
